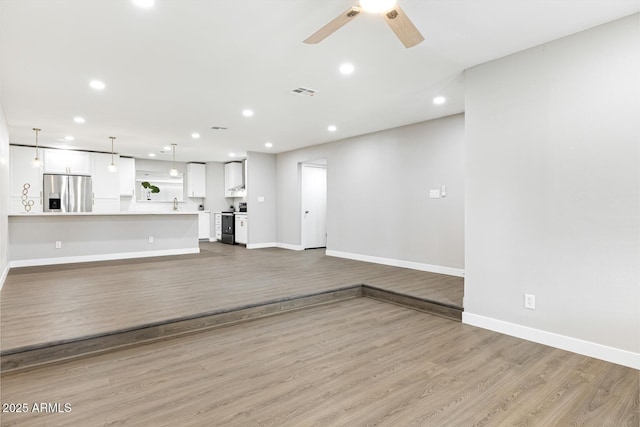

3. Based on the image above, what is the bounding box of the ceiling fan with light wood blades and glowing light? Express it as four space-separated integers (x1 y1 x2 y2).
304 0 424 48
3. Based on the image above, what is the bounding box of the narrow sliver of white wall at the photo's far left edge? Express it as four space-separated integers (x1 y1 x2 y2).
0 100 9 289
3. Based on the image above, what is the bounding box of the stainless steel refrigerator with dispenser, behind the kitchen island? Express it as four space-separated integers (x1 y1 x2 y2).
42 174 93 212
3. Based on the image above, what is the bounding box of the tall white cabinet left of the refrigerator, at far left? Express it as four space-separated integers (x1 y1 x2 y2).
9 145 43 212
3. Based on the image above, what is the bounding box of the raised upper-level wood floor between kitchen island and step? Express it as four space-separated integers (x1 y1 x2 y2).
0 243 463 351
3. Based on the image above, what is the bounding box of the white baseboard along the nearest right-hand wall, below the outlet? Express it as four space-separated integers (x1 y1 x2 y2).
462 311 640 369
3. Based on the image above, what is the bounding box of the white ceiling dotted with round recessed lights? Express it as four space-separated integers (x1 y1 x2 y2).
0 0 640 161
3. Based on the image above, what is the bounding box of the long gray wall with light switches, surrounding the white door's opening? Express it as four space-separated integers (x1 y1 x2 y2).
277 114 464 269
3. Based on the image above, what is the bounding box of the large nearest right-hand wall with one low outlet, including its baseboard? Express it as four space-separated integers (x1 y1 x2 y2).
464 15 640 367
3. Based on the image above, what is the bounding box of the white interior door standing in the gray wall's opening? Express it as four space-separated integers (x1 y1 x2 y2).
301 165 327 249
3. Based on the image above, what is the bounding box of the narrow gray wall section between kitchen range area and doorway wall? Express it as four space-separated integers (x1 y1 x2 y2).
246 152 276 247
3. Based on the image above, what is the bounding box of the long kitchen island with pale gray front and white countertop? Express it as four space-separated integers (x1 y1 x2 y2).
9 211 200 267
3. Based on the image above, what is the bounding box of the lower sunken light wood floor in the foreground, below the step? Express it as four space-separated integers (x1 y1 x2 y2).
1 298 640 427
